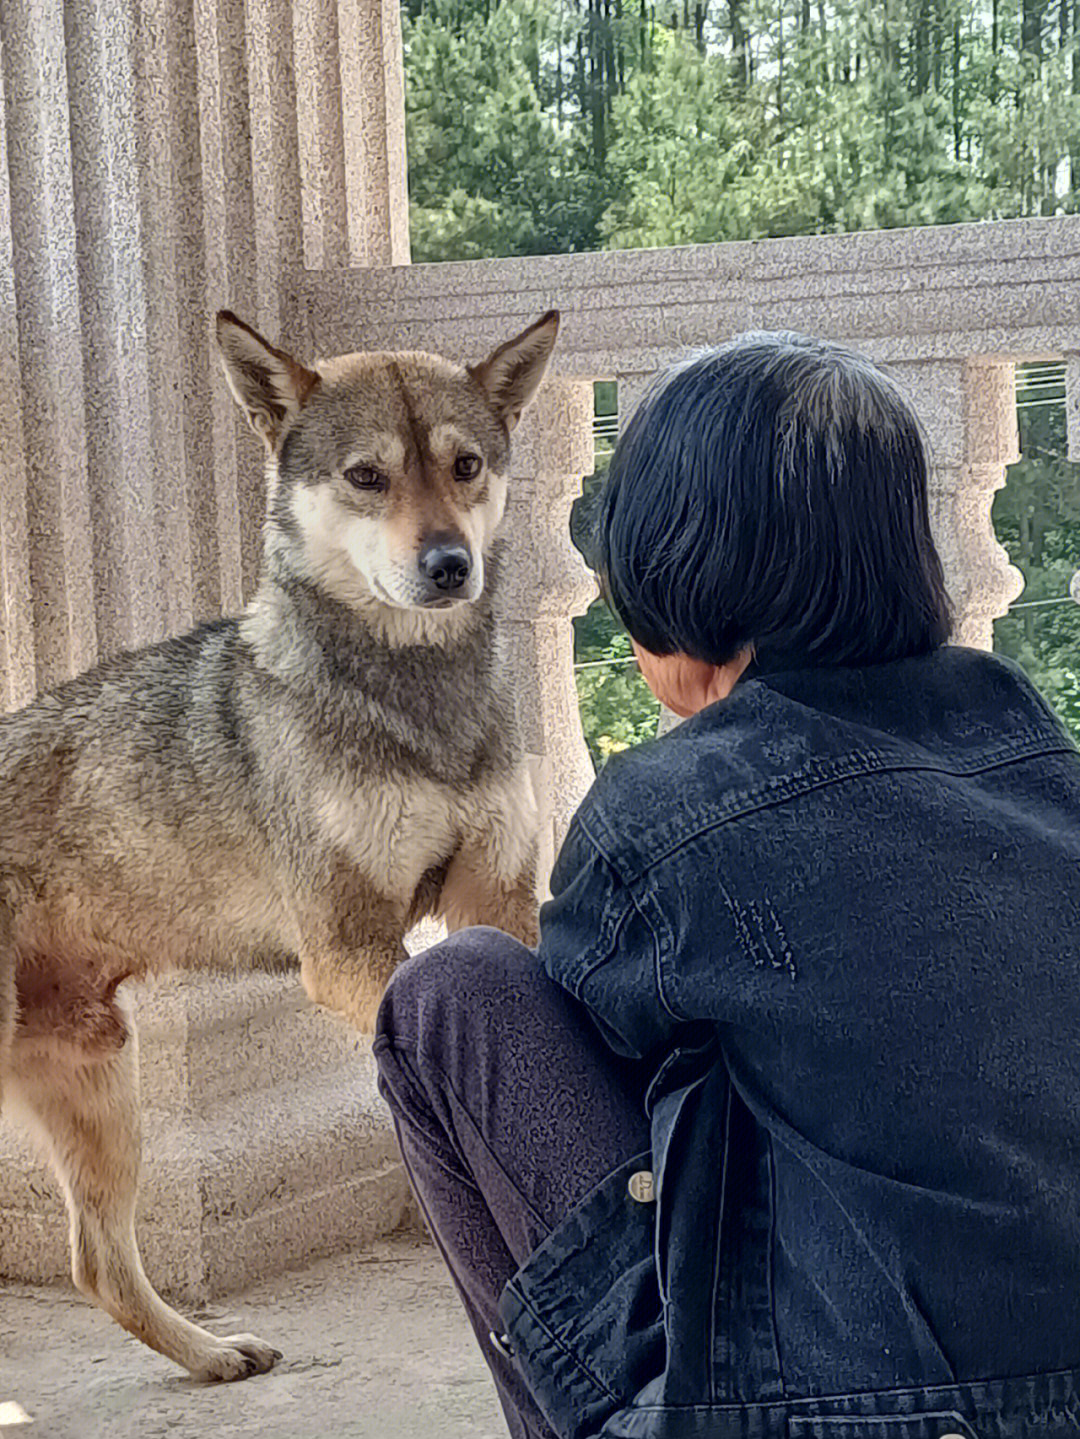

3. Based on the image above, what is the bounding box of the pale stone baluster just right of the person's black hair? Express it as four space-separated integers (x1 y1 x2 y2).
889 360 1024 649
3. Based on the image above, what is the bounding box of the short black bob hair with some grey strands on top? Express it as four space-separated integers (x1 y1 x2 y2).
591 334 951 669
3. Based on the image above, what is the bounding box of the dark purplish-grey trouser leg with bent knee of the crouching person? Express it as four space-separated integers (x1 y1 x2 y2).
375 930 650 1439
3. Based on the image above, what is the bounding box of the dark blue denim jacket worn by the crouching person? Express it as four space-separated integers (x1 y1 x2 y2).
500 648 1080 1439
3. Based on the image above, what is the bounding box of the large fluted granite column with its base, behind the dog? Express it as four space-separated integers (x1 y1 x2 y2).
0 0 408 1301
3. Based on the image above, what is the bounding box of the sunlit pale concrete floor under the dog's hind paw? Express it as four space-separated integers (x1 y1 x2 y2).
0 1238 506 1439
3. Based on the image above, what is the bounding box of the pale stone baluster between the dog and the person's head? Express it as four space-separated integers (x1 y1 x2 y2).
502 380 595 882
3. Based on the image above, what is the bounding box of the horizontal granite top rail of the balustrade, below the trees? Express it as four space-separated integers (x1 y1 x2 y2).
302 216 1080 378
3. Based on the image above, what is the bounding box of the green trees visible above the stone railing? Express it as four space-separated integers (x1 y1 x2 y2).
406 0 1080 260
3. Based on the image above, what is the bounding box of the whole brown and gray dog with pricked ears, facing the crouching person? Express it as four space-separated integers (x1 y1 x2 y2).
0 312 558 1379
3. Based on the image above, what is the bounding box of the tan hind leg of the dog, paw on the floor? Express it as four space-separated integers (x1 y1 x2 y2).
9 997 280 1380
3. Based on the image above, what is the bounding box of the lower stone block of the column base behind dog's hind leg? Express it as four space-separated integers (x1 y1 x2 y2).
0 1042 416 1302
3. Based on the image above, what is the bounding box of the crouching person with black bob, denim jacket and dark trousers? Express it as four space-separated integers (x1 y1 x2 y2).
375 334 1080 1439
